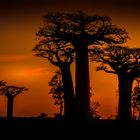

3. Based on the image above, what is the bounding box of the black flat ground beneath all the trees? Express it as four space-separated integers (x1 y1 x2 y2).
0 117 140 140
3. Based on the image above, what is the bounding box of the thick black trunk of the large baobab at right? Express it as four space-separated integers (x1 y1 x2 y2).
118 75 133 122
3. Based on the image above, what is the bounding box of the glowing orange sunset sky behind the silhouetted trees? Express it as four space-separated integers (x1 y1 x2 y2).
0 0 140 118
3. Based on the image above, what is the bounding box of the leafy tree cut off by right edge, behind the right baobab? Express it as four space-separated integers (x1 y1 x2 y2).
131 78 140 120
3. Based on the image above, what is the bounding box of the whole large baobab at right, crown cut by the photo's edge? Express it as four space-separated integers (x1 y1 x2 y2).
91 46 140 121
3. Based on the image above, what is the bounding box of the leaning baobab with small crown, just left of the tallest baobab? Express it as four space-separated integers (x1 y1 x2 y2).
33 40 75 119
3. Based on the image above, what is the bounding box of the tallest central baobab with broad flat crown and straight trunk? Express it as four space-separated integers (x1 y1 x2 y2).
34 11 128 119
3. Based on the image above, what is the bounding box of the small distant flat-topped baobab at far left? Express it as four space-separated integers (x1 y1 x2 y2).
0 85 28 118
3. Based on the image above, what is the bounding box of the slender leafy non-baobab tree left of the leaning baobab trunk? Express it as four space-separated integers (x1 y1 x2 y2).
49 70 64 115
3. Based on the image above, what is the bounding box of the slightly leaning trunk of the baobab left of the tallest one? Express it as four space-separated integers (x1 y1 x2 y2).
61 64 75 119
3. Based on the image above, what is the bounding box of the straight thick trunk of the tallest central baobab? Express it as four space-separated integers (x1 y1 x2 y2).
75 45 90 121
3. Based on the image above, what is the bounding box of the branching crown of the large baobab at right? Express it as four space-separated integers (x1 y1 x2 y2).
91 45 140 78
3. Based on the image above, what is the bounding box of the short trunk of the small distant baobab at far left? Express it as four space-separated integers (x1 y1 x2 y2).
7 97 14 118
